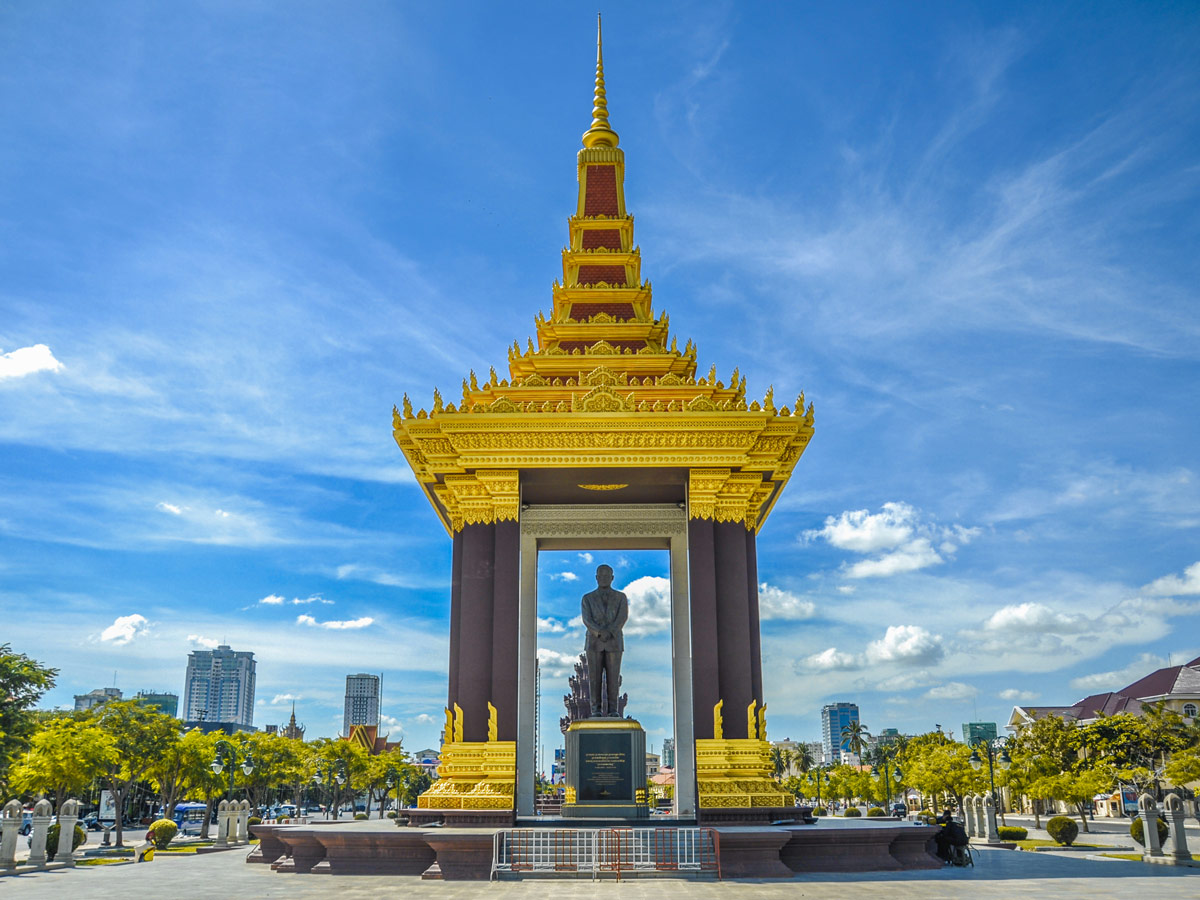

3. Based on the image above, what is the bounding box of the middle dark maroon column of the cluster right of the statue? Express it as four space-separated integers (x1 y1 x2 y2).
713 522 754 738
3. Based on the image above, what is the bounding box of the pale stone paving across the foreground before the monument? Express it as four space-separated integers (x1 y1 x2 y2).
0 850 1200 900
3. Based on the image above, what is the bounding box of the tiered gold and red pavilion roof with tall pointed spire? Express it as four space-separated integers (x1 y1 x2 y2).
392 21 812 533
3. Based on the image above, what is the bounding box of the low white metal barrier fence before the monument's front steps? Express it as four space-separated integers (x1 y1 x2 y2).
492 828 721 881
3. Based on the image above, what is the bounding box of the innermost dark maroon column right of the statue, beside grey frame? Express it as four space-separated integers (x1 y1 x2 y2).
688 518 721 739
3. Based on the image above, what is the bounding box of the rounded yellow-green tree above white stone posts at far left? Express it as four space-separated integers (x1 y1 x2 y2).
12 715 116 812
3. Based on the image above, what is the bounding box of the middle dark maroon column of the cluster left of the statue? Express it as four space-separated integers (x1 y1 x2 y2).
458 524 496 740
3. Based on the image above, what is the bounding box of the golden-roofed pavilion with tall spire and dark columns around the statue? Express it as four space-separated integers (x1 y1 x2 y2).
392 17 812 823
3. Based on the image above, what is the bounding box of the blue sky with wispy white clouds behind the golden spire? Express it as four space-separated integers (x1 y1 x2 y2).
0 2 1200 752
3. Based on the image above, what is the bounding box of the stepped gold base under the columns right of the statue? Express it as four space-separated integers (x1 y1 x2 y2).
696 738 794 809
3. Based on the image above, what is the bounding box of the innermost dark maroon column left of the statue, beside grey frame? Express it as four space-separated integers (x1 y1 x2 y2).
491 522 521 740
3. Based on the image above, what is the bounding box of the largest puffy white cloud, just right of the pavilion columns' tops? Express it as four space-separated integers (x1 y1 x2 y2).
803 503 979 578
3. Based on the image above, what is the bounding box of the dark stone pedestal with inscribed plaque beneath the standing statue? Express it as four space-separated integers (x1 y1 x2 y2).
562 719 650 820
